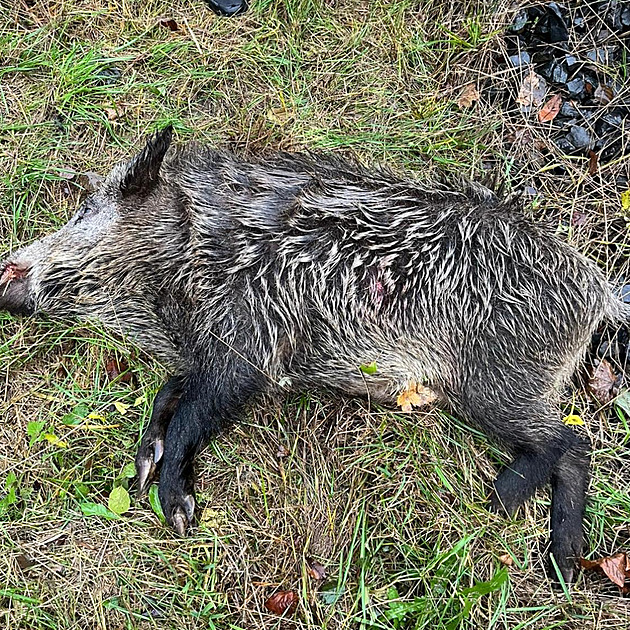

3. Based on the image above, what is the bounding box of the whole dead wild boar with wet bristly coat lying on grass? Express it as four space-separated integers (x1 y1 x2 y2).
0 128 627 582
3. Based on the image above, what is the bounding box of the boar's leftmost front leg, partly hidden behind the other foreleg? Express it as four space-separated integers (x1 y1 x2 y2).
136 376 184 496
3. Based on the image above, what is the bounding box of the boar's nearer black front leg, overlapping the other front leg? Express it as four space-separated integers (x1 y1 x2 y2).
159 361 263 536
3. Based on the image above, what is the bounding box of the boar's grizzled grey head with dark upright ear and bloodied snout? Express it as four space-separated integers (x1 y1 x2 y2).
0 126 186 368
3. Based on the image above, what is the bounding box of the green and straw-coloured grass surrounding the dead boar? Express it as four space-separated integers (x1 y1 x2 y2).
0 0 630 630
